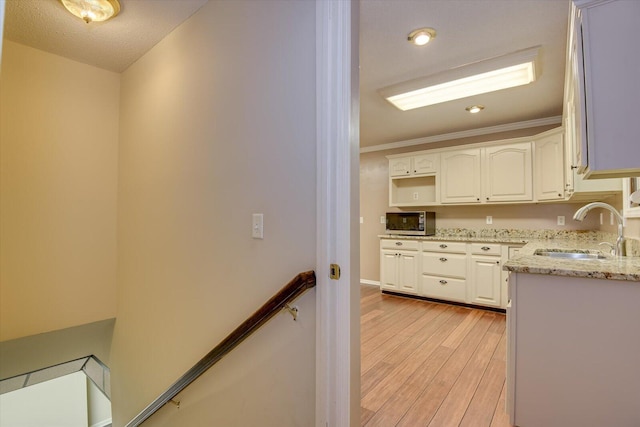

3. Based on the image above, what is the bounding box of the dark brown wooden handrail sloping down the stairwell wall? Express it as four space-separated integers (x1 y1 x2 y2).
126 271 316 427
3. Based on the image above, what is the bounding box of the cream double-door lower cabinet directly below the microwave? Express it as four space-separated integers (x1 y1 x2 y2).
380 239 419 294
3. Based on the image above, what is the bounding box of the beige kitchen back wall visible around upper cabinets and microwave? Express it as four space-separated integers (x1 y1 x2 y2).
360 128 599 282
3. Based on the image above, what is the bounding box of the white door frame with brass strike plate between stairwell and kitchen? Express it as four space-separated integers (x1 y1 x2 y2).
316 0 360 427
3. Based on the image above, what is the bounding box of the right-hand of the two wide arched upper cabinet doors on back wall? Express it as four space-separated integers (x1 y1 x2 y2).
483 142 533 202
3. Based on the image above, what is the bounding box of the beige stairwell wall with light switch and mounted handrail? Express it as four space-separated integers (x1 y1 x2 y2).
111 1 316 426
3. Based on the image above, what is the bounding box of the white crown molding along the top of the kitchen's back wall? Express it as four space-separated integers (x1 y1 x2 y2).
360 116 562 154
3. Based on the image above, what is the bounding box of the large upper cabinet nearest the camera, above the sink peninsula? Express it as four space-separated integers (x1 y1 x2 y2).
565 0 640 178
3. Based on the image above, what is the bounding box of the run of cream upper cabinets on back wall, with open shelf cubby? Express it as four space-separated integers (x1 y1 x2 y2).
387 125 624 207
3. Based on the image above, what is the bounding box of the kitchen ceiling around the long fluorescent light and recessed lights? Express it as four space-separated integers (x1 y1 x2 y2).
360 0 570 147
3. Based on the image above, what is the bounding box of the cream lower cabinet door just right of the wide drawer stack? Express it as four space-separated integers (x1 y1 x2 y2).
469 256 502 307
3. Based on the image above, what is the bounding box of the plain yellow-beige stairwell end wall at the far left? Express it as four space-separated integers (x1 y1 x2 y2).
0 40 120 341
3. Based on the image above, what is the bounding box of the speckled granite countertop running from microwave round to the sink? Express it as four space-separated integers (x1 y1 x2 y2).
378 229 640 282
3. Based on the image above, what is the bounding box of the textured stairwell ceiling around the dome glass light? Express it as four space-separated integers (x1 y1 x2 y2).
4 0 207 72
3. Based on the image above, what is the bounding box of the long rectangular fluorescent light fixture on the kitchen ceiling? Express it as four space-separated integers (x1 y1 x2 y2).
378 47 539 111
